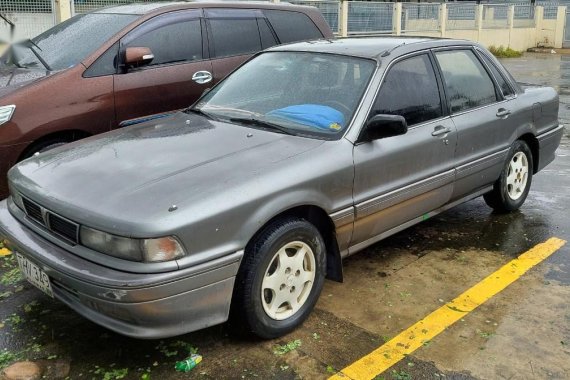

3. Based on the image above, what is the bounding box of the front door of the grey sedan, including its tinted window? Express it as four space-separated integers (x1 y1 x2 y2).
351 52 457 252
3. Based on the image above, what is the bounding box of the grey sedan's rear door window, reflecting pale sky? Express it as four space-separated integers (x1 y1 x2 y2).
435 50 497 113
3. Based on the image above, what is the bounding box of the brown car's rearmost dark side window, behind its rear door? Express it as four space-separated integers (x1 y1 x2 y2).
263 10 323 43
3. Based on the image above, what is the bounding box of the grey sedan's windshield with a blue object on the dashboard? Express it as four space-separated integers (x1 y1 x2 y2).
195 52 375 139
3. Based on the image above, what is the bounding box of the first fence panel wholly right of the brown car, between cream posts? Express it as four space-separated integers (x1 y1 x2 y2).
348 1 394 35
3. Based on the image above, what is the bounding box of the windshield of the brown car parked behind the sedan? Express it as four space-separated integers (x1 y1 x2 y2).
2 13 139 70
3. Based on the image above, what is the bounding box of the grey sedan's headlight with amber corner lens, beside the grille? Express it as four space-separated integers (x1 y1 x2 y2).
80 227 186 262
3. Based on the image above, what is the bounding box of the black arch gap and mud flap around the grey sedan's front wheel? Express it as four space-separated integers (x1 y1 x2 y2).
247 205 343 282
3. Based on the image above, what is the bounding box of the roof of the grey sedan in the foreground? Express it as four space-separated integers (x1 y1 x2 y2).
269 36 476 60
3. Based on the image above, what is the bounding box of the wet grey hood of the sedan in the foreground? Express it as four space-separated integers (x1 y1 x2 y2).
9 112 323 232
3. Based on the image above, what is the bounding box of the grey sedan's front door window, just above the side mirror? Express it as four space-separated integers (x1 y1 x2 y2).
373 54 442 125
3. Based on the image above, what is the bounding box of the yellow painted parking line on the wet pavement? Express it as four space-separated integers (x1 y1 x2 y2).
329 238 566 380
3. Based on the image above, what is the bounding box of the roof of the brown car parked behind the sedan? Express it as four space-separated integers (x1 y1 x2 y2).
92 0 316 16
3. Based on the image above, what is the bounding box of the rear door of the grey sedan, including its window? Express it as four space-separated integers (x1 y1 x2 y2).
434 47 516 200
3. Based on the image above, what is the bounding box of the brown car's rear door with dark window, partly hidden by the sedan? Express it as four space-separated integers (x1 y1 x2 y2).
204 8 277 84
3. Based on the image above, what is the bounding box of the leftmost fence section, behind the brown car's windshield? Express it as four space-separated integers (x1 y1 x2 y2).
0 0 55 41
